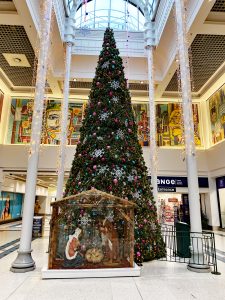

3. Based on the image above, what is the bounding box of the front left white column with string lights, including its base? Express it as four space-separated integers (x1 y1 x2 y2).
11 0 52 273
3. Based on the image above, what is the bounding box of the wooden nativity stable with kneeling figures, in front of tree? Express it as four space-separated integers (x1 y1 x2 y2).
49 189 135 269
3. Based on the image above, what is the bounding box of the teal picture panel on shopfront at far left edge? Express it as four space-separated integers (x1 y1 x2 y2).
0 192 23 223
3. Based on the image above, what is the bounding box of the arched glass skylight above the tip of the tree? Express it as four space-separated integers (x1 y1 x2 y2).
65 0 158 31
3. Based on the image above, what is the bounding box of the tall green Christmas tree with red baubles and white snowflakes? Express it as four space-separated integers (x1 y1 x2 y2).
65 28 165 263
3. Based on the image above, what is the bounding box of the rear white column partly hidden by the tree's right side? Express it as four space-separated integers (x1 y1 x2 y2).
145 18 159 217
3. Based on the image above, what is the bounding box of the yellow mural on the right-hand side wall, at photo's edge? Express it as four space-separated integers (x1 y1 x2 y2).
208 85 225 144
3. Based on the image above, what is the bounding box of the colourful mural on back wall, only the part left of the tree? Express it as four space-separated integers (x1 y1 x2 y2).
7 99 84 145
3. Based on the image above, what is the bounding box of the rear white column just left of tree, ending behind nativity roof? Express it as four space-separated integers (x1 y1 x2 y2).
56 18 75 199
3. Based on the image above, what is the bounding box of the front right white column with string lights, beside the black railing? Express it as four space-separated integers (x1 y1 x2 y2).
175 0 208 271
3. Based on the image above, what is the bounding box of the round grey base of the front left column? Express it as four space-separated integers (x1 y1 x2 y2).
10 250 36 273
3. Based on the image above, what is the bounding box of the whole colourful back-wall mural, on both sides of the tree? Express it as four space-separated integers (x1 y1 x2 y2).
7 99 201 146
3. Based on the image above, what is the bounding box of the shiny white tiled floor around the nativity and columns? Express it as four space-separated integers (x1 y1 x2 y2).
0 223 225 300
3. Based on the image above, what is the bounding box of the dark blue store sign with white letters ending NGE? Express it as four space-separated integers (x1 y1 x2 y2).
149 176 209 188
